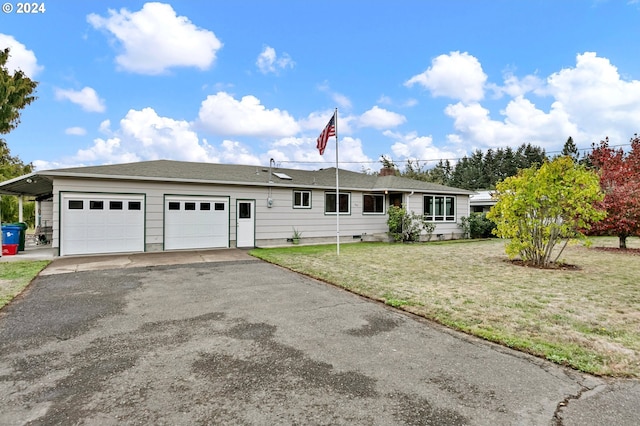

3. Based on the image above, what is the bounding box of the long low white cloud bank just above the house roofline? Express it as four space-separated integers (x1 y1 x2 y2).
41 104 373 171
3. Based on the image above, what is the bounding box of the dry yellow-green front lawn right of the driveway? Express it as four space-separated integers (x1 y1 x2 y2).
251 237 640 378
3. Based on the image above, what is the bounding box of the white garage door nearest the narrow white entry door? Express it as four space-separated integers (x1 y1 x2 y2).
164 195 229 250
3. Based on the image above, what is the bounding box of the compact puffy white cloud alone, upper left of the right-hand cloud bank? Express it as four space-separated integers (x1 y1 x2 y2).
405 52 487 102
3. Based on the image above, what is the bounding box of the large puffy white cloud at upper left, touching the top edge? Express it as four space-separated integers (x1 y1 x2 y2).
87 3 222 75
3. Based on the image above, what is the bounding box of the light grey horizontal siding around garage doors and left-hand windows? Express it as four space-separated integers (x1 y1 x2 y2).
52 178 410 252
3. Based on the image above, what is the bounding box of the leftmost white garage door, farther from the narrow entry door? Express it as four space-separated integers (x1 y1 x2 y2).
60 193 145 256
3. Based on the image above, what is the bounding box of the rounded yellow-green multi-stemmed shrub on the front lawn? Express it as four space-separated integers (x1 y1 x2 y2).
487 156 605 267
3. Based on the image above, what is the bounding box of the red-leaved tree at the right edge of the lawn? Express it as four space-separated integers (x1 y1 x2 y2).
589 135 640 249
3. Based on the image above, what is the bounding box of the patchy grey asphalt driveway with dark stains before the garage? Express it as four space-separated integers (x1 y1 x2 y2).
0 255 640 425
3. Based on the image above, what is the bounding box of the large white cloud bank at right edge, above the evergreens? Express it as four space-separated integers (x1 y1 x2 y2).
438 52 640 151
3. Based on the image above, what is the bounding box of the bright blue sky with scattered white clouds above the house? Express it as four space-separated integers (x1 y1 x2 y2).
0 0 640 171
